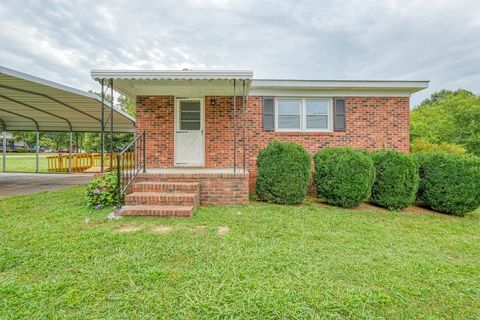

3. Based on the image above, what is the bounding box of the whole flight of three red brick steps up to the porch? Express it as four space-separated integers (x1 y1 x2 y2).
119 181 200 217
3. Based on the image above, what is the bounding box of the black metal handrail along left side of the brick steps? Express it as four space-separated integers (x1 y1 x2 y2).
117 131 146 207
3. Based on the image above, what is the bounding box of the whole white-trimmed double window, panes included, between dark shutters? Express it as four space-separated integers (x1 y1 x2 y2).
275 98 333 132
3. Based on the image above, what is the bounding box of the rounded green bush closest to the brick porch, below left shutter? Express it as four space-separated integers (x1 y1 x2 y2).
256 141 312 204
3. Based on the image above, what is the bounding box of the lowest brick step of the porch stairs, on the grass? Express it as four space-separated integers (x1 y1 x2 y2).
119 205 195 217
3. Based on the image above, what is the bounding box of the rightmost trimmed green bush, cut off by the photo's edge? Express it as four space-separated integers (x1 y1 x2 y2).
416 152 480 216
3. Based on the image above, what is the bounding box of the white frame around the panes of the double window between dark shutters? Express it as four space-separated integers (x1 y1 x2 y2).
275 97 333 132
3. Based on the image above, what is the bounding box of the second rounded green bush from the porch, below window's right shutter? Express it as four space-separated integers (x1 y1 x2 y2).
313 147 375 208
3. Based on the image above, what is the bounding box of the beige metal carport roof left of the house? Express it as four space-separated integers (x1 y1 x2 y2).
0 66 135 132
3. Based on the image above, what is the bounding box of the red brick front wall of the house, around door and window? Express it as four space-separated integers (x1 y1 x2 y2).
136 96 410 191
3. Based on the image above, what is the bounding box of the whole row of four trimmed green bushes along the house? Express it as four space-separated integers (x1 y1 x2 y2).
257 141 480 216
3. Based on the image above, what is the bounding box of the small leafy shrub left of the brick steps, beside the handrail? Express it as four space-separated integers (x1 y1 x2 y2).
85 172 118 207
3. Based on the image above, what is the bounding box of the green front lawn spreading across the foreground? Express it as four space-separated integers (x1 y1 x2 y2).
0 187 480 319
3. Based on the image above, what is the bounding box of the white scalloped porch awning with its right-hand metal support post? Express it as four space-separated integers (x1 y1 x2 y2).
91 69 253 172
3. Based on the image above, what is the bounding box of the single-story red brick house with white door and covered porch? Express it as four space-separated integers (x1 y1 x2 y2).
92 70 428 215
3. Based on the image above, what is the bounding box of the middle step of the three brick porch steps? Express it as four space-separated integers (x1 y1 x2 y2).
125 192 199 206
